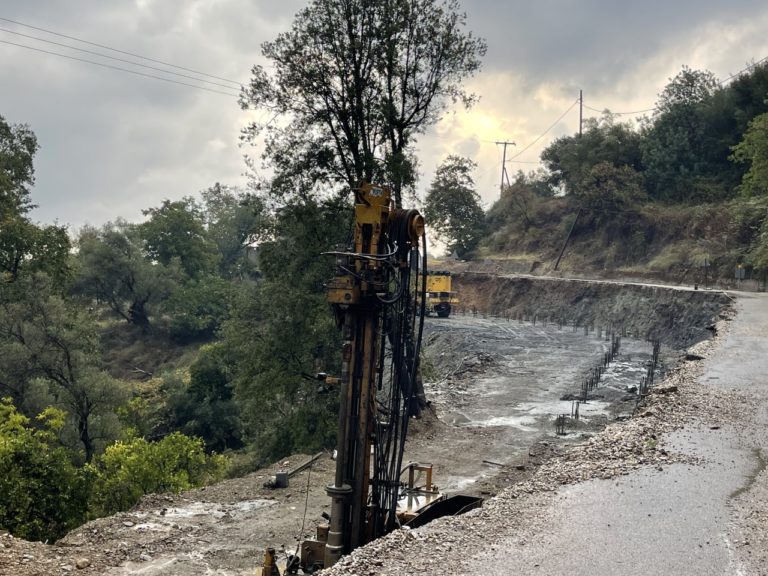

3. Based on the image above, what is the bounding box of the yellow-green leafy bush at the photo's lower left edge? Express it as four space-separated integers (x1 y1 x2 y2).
0 398 88 540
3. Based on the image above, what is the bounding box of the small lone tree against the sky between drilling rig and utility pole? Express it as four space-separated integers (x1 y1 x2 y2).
424 156 484 256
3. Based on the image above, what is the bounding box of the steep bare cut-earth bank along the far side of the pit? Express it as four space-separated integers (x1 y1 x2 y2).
453 272 731 349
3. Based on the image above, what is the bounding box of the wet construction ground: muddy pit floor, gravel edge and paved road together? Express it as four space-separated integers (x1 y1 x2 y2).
0 286 768 576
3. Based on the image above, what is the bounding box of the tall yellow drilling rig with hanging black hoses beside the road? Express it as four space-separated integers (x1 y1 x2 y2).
262 183 479 576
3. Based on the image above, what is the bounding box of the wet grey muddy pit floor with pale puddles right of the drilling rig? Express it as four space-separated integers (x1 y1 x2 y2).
422 316 651 492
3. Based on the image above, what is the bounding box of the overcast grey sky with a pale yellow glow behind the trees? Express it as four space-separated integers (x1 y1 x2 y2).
0 0 768 229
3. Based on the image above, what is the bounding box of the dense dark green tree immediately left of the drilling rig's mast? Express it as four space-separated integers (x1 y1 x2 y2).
224 199 342 461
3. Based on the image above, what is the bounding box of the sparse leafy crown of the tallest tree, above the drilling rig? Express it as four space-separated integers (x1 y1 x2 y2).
241 0 486 205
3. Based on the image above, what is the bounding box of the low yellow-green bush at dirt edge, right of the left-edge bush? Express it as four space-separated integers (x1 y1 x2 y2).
91 432 226 516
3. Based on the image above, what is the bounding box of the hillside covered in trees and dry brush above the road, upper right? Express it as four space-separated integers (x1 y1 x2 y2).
474 63 768 282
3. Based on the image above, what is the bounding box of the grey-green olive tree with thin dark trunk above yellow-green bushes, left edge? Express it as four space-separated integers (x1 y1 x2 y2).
0 274 127 461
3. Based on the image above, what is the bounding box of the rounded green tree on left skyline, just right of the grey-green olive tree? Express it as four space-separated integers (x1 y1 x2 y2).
137 197 217 278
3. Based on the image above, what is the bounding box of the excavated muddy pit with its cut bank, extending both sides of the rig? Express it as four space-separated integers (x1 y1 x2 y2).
0 274 730 576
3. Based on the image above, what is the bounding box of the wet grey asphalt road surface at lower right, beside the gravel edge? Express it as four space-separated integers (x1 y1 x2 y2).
476 294 768 576
